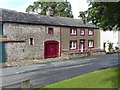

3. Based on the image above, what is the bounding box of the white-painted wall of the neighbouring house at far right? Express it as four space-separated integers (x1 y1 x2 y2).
100 30 120 52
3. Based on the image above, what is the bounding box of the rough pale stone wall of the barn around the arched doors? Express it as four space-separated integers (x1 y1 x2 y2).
3 23 60 61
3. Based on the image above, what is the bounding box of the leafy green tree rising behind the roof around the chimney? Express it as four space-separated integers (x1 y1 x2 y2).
26 1 73 18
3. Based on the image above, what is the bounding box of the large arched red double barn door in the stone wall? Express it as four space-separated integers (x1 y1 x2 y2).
44 40 59 59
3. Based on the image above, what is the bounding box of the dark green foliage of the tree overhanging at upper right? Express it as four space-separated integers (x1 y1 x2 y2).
79 1 120 30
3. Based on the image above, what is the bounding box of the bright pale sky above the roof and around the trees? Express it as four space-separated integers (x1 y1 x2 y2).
0 0 88 19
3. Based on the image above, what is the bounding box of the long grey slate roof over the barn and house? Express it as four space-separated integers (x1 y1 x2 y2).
0 8 98 28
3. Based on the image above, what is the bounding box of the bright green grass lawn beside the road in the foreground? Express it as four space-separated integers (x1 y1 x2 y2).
34 66 120 90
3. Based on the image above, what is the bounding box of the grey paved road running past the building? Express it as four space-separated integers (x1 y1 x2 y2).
0 54 120 88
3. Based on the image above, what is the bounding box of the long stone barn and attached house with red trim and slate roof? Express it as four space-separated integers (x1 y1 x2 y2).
0 9 100 62
